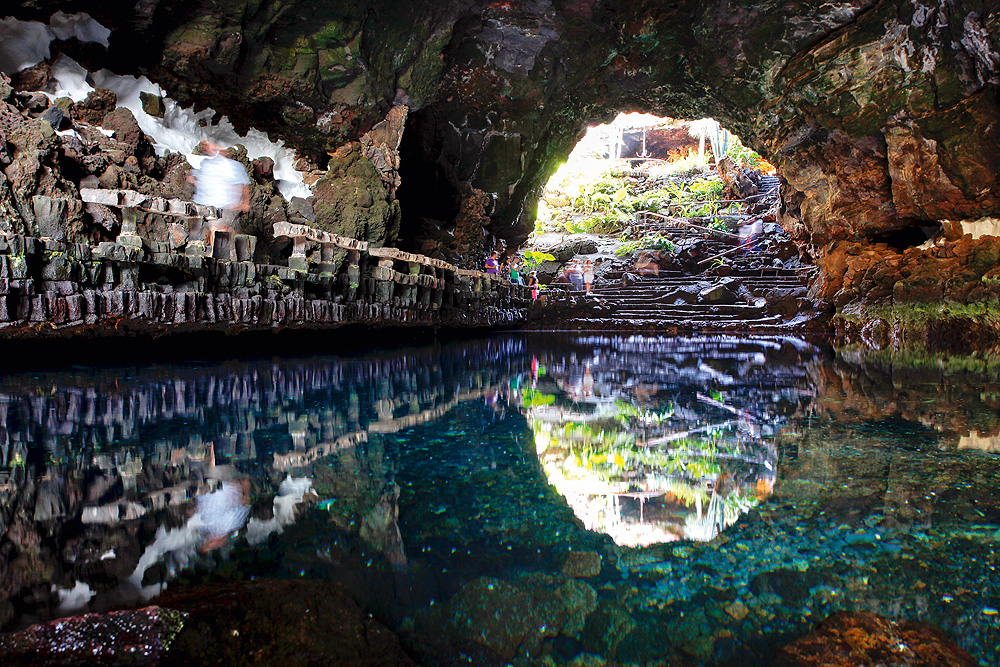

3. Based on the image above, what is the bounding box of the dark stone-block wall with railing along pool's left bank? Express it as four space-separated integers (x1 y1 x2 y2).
0 188 531 337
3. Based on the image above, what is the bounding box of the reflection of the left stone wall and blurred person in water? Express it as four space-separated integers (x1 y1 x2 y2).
0 341 524 626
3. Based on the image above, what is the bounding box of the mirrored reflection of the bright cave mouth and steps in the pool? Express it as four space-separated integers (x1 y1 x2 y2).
524 337 815 546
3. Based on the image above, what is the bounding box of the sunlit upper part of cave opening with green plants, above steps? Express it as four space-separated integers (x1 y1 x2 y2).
532 113 777 258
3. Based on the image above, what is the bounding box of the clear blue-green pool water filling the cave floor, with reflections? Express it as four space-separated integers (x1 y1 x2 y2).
0 335 1000 665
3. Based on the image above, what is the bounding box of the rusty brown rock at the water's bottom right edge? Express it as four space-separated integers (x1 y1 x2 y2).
774 612 979 667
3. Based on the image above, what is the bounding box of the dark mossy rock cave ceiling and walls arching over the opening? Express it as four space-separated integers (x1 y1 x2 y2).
5 0 1000 320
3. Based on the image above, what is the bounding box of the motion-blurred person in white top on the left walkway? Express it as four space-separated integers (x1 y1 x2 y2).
194 141 250 256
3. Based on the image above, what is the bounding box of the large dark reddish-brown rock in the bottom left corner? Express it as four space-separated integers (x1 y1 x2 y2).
0 581 416 667
